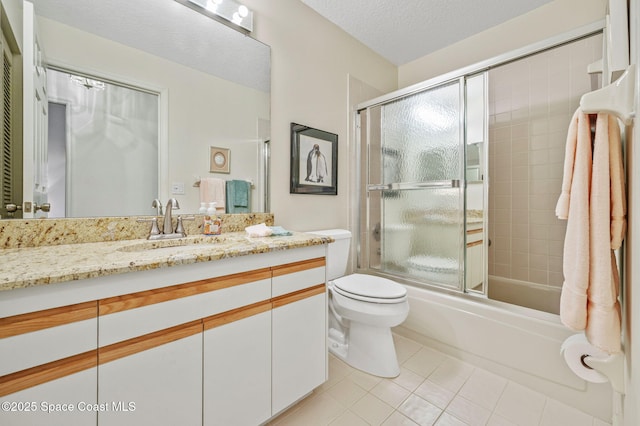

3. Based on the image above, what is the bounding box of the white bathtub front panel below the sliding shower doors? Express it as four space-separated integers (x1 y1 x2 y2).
394 285 612 422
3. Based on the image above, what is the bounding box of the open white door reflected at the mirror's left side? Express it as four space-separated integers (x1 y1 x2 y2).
22 2 48 218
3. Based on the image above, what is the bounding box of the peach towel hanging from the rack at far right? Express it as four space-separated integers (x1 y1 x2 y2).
556 110 626 353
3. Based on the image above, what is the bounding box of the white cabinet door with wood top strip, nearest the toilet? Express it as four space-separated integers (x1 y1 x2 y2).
272 292 327 415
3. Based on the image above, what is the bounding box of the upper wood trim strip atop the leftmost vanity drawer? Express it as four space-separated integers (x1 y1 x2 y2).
0 301 98 338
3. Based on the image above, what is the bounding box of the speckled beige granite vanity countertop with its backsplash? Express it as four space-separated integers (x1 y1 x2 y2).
0 213 333 292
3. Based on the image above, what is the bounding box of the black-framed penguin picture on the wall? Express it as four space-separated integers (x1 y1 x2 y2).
289 123 338 195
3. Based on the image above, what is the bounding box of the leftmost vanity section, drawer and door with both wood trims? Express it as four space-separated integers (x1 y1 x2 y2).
0 302 98 426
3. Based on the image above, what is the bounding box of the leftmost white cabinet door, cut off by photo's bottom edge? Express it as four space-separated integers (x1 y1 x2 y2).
0 367 97 426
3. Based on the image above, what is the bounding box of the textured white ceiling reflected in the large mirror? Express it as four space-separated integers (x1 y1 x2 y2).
30 0 271 92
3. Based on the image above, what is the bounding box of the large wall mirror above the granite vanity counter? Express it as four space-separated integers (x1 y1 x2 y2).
0 0 271 219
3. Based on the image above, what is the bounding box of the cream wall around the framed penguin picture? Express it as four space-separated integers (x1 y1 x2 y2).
243 0 397 230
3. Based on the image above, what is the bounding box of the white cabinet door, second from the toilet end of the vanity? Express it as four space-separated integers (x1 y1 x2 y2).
203 303 271 426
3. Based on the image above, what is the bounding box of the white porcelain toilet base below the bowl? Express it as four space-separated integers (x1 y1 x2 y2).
329 321 400 378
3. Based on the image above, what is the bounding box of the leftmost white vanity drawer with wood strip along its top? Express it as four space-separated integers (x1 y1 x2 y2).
0 302 98 376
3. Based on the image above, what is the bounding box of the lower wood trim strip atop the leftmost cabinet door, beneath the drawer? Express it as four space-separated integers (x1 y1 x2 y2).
0 349 98 397
